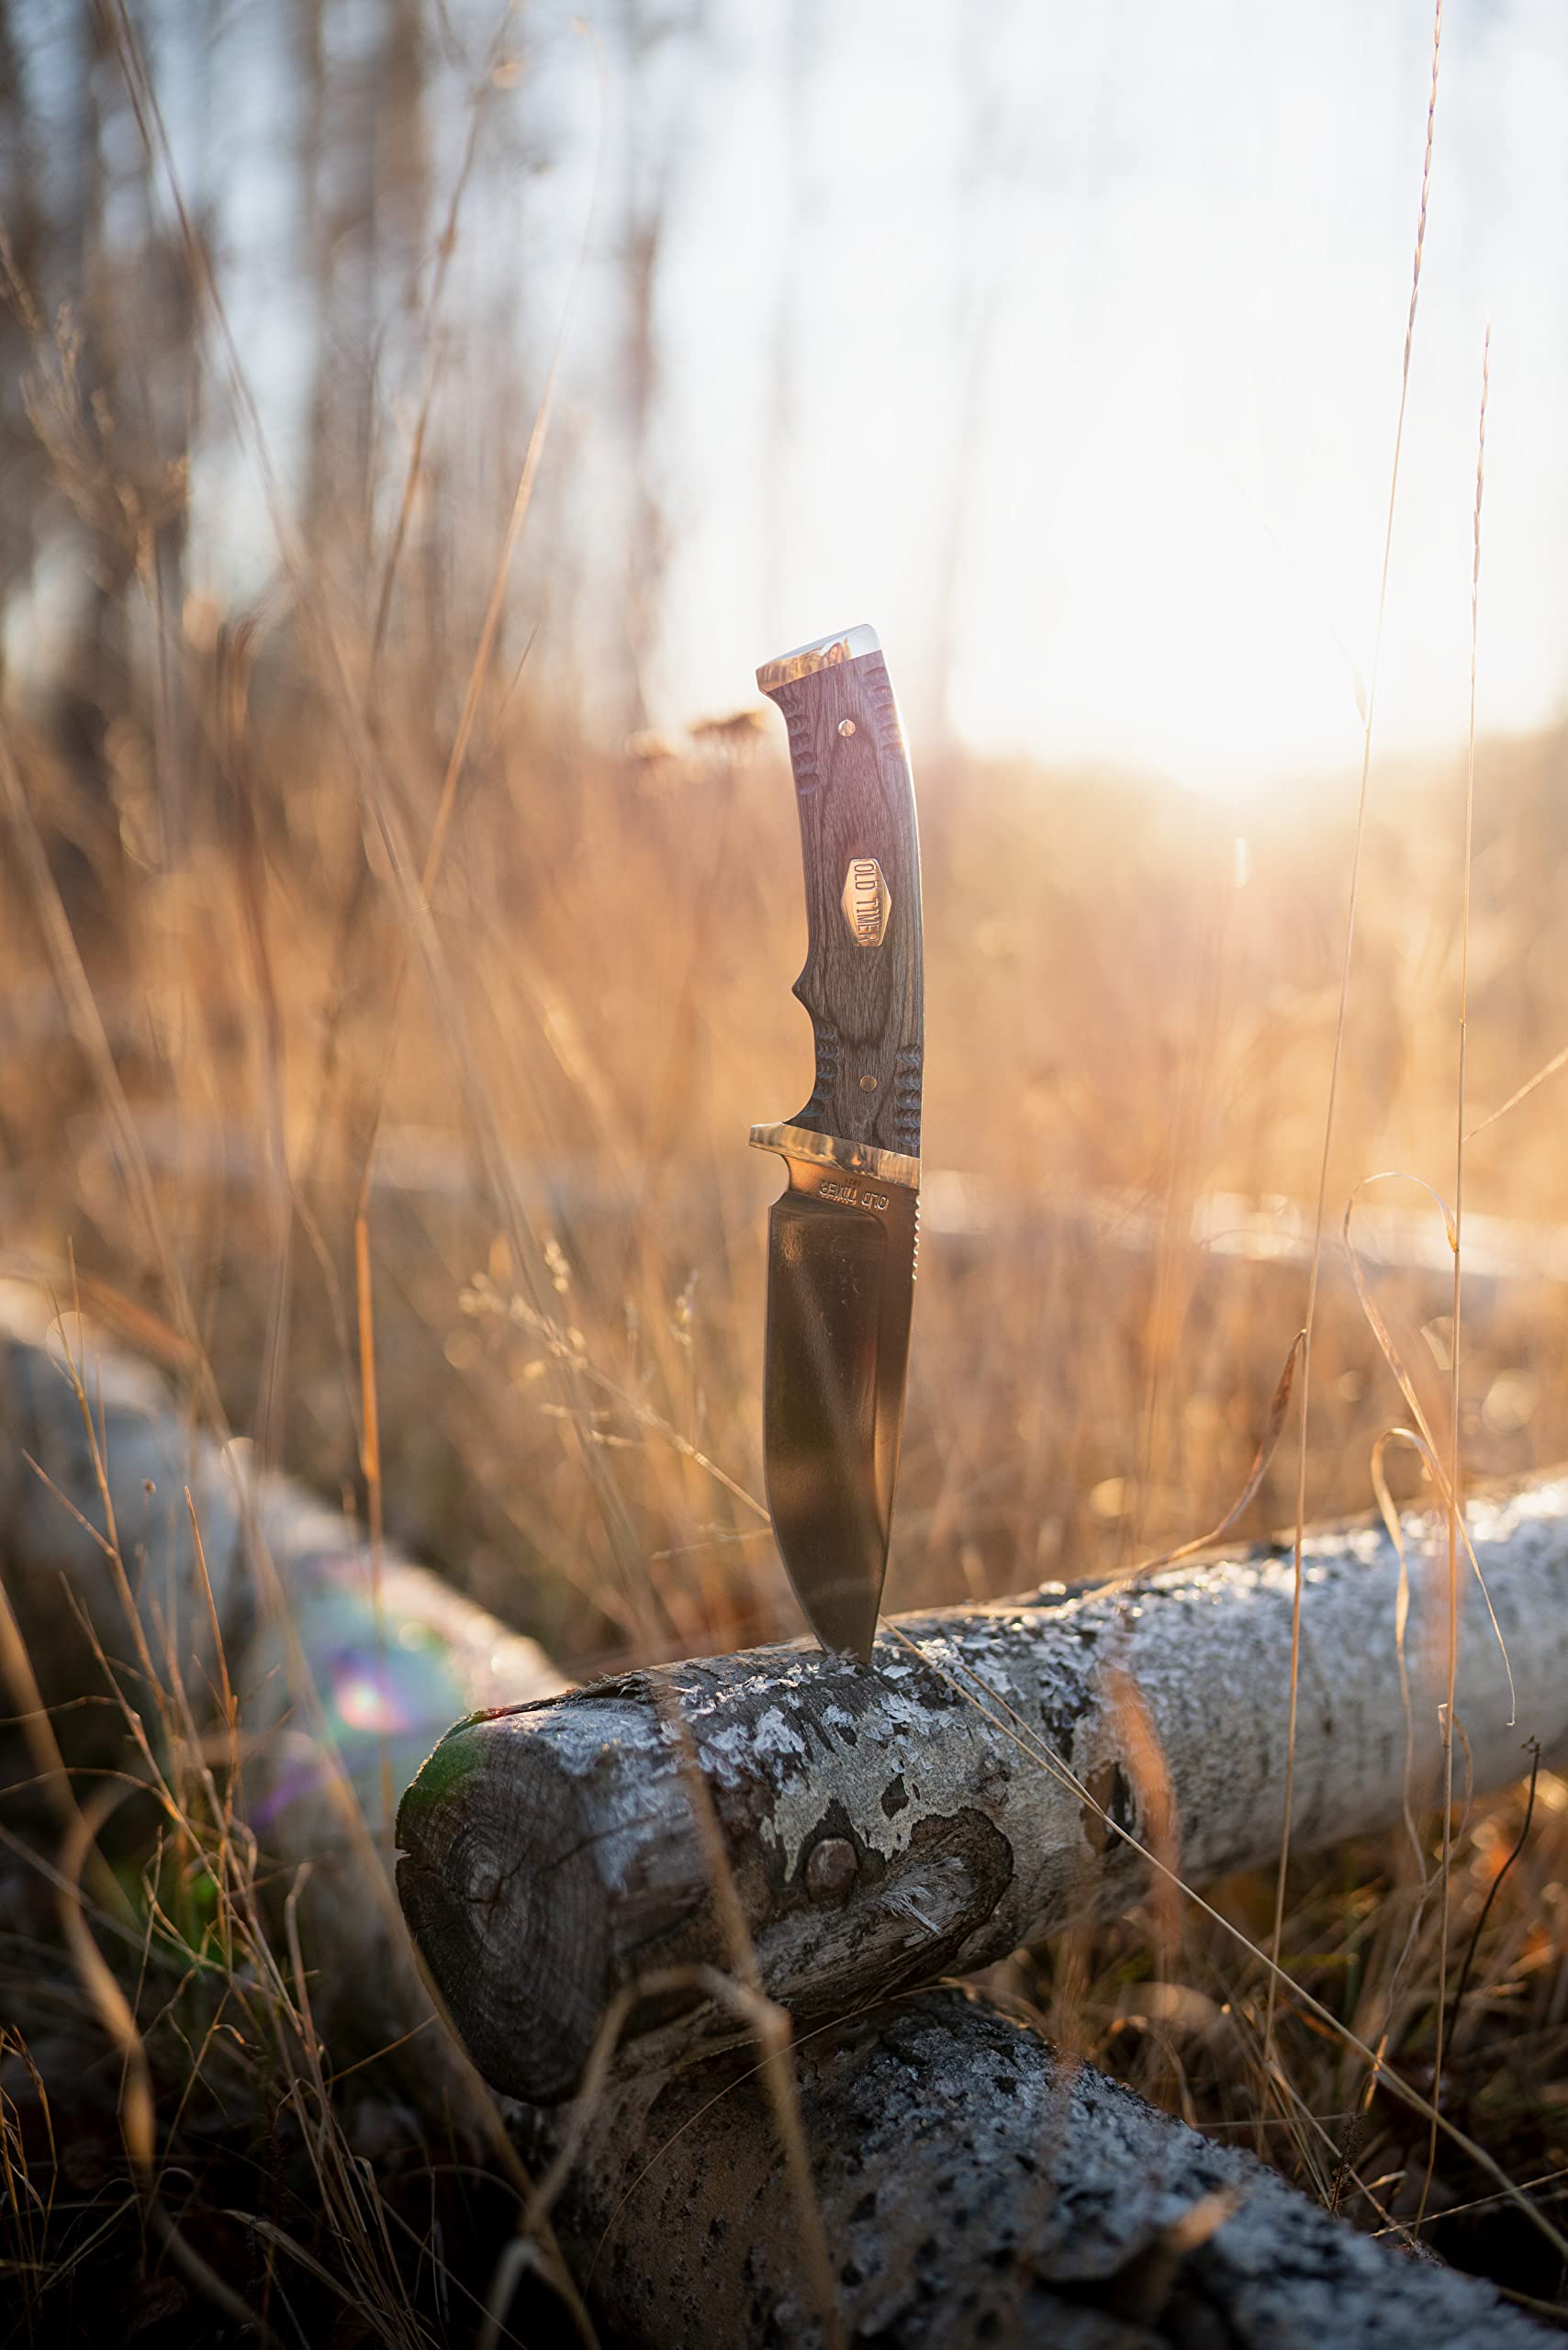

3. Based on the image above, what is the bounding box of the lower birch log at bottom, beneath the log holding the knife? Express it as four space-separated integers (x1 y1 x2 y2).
536 1988 1551 2350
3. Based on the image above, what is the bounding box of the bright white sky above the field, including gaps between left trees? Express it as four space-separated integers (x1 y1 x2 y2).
18 0 1568 792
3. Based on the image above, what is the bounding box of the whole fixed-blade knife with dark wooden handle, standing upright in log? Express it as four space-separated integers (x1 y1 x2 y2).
752 628 924 1663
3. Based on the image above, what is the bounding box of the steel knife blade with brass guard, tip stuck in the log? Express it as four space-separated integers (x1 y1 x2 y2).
752 1125 919 1662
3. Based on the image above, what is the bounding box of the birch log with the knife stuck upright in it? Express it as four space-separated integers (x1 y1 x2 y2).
398 1481 1568 2101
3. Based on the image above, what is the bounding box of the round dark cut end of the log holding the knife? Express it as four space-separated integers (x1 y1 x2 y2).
398 1720 609 2103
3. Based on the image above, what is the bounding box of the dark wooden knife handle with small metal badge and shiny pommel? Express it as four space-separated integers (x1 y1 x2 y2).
757 628 924 1157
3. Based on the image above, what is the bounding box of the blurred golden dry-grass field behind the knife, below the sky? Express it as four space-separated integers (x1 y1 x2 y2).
5 695 1568 1666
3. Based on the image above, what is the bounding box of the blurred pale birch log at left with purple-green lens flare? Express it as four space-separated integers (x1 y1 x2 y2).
0 1281 565 2042
